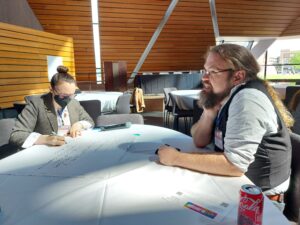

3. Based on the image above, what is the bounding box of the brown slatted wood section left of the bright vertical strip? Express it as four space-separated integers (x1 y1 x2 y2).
28 0 96 82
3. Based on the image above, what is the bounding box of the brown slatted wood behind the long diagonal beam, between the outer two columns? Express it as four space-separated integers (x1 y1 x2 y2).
99 0 215 76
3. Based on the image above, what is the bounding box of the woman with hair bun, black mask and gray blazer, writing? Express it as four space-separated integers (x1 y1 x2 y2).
10 66 94 148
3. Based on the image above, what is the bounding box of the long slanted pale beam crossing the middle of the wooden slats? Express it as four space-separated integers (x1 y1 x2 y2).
127 0 179 84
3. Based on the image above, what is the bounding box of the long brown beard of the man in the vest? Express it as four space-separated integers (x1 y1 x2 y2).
198 89 230 109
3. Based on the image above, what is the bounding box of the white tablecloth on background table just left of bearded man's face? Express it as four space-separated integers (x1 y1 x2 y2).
171 90 201 110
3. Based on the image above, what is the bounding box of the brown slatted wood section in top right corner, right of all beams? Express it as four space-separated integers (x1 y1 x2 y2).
216 0 300 37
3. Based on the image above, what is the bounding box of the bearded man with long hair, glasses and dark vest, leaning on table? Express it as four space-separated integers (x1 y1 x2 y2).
158 44 293 209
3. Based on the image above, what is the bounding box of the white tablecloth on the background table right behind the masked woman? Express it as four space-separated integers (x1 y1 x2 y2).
75 91 123 113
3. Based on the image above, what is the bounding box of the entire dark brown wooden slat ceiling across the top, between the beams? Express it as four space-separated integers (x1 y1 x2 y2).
28 0 300 80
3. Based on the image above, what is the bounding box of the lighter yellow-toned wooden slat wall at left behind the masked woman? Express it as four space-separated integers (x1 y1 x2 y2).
0 23 75 108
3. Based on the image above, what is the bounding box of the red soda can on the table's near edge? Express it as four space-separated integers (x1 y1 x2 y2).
237 184 264 225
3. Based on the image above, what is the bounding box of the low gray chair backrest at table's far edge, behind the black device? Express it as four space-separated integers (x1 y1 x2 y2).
96 113 144 126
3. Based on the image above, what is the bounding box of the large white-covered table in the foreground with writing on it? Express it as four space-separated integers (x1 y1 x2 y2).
0 125 289 225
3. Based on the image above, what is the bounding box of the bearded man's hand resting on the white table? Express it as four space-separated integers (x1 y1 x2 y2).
157 145 180 166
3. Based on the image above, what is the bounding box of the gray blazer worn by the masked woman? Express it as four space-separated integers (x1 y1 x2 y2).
10 93 94 146
